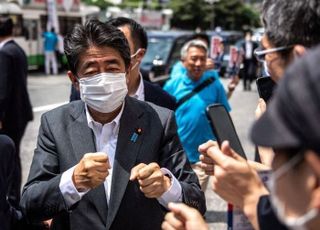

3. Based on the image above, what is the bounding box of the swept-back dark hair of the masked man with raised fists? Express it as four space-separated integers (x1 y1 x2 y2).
64 19 131 75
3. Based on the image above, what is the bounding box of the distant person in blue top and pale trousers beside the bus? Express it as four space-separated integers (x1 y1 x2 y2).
42 28 58 75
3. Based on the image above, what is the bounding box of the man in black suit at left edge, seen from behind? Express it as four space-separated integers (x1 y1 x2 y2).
0 17 33 206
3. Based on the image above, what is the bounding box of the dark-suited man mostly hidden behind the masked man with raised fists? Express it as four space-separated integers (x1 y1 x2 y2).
70 17 176 110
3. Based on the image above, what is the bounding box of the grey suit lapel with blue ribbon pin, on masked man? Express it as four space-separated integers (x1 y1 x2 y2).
107 97 146 229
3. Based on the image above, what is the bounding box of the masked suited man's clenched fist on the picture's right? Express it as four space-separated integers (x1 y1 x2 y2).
130 163 171 198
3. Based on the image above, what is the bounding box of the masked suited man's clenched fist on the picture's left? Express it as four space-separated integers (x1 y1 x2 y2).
72 152 111 192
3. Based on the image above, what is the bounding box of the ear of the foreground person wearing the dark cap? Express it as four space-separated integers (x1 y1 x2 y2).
305 151 320 210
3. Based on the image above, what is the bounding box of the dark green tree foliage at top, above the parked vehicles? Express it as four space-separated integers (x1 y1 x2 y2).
170 0 260 30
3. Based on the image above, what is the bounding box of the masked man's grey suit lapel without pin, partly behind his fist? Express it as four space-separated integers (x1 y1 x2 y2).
69 102 107 224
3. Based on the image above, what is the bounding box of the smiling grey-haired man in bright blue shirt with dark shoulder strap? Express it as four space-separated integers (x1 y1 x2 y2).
164 40 231 191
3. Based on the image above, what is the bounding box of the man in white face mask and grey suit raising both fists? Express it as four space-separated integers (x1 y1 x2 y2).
21 19 206 230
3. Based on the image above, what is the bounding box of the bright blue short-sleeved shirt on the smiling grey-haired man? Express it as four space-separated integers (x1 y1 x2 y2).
164 70 231 164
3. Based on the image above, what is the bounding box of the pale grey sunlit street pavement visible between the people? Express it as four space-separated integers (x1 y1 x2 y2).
21 73 258 230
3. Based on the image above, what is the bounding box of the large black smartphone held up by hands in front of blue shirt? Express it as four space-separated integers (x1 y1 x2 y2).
206 104 247 159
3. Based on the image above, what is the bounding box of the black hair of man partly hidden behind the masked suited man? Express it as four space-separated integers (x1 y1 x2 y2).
106 17 148 51
